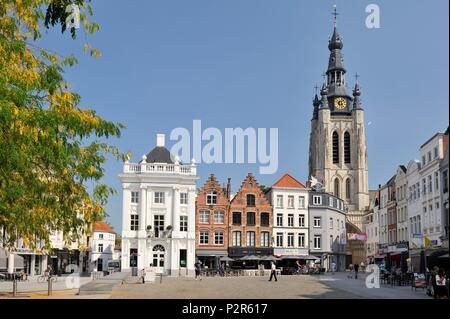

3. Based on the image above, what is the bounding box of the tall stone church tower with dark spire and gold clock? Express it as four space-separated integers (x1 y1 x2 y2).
309 8 369 256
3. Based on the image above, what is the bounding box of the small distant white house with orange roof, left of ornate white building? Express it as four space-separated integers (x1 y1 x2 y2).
89 222 116 271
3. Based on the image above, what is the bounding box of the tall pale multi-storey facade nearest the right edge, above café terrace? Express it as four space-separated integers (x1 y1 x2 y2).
419 133 444 247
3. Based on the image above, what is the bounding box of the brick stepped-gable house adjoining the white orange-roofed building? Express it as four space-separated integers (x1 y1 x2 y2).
228 173 273 259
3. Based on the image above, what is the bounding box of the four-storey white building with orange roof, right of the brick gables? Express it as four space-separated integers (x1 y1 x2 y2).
266 174 309 258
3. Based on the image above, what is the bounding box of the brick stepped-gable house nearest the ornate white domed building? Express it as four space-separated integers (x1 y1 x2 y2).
195 174 230 269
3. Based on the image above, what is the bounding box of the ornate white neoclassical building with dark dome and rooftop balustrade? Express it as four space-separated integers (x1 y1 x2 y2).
119 134 199 276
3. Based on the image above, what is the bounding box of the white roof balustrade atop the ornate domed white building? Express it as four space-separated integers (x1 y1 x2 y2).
123 162 197 176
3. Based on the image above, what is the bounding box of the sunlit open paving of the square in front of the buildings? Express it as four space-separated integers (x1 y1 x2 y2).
111 273 429 299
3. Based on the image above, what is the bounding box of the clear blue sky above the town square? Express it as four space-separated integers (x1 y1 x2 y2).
40 0 449 232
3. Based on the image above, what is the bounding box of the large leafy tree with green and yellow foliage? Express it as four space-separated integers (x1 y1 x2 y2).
0 0 124 248
